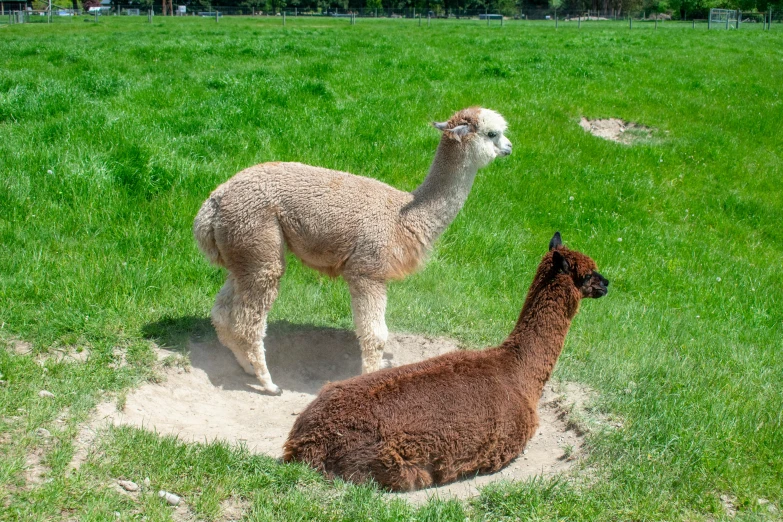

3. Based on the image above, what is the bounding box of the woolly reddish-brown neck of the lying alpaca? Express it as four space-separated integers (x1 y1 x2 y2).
502 277 579 400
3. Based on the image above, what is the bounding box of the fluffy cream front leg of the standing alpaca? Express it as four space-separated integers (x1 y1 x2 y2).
348 278 389 373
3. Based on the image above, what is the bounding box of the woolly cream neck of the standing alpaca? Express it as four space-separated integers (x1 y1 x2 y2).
402 137 478 246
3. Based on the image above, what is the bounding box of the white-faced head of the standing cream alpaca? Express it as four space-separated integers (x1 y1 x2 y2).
432 107 511 168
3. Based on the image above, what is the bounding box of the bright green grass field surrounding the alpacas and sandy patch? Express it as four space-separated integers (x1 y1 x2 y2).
0 17 783 521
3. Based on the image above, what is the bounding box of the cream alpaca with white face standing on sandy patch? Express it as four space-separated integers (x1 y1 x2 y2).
193 107 511 394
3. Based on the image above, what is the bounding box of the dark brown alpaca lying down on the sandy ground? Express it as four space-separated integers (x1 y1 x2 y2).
283 232 609 491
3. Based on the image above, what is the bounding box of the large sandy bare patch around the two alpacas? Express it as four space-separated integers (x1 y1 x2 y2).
91 327 586 503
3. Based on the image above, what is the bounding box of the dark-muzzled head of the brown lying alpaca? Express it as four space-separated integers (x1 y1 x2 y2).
542 232 609 299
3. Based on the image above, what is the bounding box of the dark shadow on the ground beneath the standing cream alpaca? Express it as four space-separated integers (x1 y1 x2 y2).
142 316 370 394
